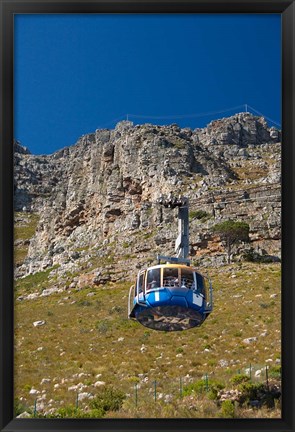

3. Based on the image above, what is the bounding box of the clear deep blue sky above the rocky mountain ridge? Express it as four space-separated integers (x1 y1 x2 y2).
14 14 281 154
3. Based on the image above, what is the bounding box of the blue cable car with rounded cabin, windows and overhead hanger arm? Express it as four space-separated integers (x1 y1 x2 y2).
128 196 213 331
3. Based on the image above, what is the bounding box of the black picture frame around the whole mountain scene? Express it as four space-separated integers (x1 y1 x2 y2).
0 0 295 432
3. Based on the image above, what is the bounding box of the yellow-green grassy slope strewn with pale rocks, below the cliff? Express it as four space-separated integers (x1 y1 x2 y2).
15 263 280 416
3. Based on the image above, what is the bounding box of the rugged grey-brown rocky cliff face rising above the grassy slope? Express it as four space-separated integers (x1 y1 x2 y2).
15 113 281 281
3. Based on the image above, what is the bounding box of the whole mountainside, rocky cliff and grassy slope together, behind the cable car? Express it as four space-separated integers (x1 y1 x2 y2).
15 113 281 417
